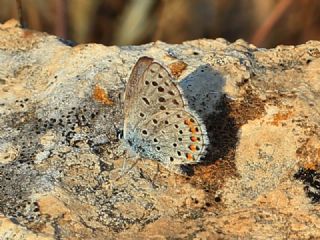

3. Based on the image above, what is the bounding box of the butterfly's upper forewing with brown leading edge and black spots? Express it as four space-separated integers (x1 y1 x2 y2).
124 57 184 139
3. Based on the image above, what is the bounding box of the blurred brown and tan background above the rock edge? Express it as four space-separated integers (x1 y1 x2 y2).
0 0 320 48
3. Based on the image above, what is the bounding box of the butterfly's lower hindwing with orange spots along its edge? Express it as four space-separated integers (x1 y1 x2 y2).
136 109 208 165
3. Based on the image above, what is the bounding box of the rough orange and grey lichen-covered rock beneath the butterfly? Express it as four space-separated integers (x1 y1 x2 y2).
0 20 320 239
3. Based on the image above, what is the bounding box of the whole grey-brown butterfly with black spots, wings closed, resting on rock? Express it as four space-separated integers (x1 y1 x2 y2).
124 57 208 172
